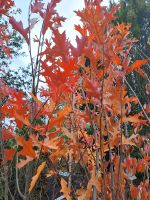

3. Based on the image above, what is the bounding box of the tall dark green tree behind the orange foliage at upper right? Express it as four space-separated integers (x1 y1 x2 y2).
110 0 150 112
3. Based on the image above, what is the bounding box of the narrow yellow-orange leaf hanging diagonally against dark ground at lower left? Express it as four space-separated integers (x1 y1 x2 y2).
29 162 46 193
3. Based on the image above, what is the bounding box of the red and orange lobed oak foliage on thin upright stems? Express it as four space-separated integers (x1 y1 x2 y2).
0 0 150 200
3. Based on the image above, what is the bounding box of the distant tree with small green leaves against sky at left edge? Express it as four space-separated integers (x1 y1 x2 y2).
0 4 31 91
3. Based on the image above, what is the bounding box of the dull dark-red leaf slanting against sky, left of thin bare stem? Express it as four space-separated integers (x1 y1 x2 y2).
9 17 30 45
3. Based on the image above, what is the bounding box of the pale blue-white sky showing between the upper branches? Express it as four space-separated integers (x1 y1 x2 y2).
12 0 117 68
